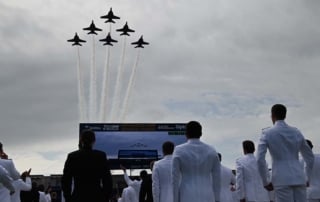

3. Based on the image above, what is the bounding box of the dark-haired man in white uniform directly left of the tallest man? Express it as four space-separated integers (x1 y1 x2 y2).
236 140 270 202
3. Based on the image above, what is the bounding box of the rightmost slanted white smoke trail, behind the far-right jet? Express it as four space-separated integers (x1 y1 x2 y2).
120 50 140 122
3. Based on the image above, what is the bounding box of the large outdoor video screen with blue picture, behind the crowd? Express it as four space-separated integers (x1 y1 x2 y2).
80 123 186 169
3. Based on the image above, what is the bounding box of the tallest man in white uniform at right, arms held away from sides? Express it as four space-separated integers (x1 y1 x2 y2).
257 104 314 202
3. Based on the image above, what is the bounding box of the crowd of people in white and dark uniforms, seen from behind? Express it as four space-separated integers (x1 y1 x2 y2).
0 104 320 202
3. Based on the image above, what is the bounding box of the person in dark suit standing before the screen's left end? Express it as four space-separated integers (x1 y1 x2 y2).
61 130 112 202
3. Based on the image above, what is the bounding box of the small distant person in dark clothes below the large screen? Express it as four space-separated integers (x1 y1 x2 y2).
139 170 153 202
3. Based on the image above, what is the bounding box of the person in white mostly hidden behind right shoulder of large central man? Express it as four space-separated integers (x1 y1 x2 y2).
218 153 236 202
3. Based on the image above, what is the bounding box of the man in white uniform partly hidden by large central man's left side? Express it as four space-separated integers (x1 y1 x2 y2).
152 141 174 202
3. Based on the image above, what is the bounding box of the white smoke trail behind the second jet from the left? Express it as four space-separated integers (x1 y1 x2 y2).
89 35 97 122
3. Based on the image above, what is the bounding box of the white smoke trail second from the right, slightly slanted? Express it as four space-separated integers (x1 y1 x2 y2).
111 36 127 122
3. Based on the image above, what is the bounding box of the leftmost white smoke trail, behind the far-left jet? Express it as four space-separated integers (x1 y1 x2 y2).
77 47 87 122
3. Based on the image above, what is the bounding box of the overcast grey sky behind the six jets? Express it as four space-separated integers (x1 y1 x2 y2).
0 0 320 175
